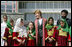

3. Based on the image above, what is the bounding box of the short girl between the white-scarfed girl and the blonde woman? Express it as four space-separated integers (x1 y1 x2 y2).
27 22 35 46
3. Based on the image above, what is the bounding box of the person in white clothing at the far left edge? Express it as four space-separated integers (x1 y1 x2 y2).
1 14 8 46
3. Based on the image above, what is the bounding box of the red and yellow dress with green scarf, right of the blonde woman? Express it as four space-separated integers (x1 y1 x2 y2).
45 18 57 46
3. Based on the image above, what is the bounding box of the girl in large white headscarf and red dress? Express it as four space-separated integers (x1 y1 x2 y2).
13 18 27 46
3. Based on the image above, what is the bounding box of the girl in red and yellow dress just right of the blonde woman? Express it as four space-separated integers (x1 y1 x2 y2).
45 17 56 46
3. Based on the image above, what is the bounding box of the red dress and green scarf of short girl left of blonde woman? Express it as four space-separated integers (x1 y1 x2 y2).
27 26 36 46
